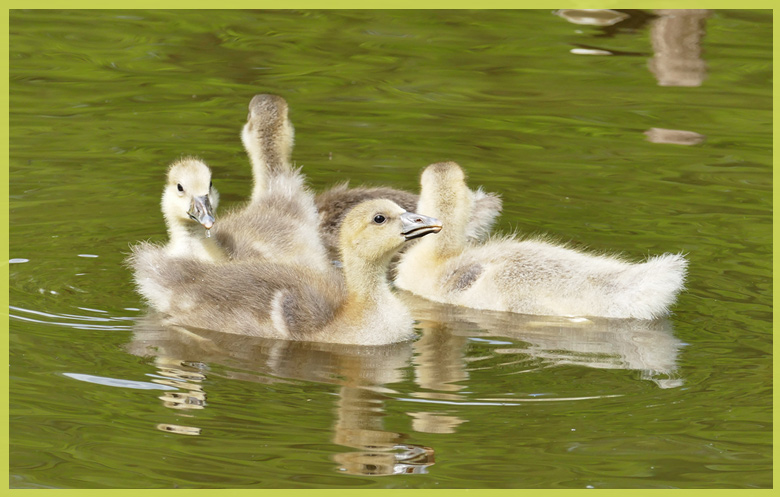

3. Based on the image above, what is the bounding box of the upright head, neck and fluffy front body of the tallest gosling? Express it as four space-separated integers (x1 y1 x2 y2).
214 95 330 269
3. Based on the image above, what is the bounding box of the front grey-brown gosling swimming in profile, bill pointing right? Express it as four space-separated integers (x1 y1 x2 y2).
134 199 441 345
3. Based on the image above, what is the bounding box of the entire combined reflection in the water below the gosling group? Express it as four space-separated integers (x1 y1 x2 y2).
128 292 683 476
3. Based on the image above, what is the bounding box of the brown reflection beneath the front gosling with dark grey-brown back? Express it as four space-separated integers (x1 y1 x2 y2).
128 315 434 476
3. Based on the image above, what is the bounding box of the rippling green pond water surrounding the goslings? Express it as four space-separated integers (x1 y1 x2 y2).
9 10 772 488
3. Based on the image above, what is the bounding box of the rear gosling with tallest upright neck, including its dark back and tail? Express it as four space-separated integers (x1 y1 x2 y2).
221 94 502 267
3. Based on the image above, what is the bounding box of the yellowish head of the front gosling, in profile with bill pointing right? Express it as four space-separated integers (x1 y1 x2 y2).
340 199 442 261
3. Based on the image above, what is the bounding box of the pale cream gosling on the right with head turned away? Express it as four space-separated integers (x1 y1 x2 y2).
395 162 688 319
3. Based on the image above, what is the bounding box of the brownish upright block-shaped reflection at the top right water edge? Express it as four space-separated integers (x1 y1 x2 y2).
648 9 709 86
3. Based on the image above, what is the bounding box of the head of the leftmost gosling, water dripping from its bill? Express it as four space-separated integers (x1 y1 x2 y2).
162 158 219 230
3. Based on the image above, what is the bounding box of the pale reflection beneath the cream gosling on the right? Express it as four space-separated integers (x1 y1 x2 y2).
402 292 684 390
